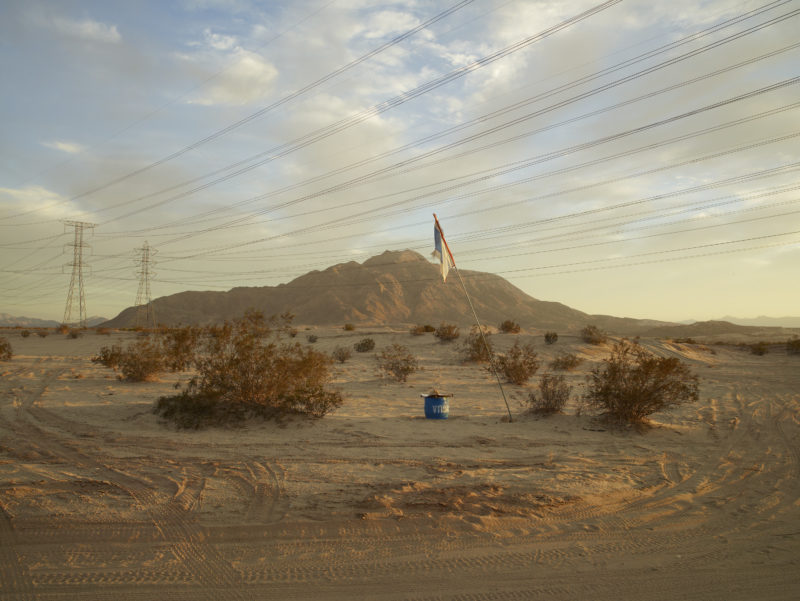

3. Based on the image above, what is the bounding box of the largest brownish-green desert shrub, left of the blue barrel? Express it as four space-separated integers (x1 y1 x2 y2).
154 312 342 427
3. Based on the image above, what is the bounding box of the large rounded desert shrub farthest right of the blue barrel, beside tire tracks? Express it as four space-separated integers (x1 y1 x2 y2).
585 339 699 424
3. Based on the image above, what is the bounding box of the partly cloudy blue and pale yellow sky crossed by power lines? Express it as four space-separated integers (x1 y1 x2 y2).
0 0 800 321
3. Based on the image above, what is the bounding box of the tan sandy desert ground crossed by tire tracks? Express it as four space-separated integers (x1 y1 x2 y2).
0 328 800 601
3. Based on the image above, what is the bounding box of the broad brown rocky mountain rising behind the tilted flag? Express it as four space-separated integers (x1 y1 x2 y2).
98 250 670 334
